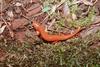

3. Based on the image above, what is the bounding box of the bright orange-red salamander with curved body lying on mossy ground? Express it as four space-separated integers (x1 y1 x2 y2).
32 21 81 42
